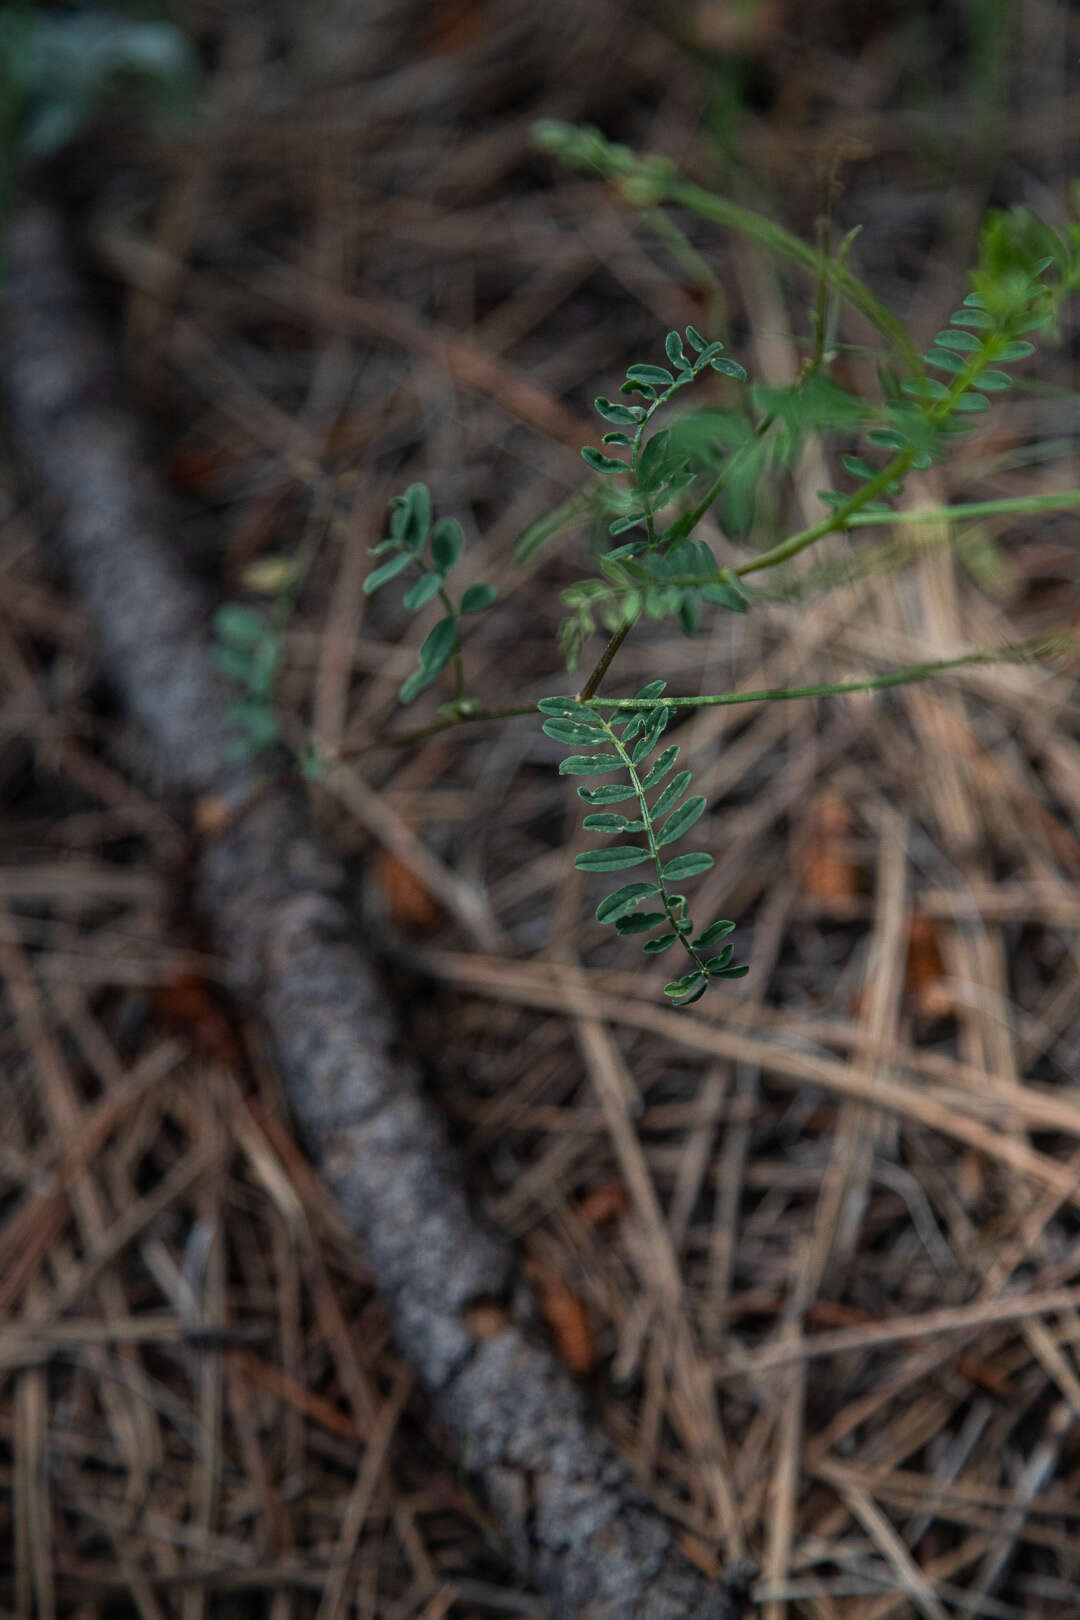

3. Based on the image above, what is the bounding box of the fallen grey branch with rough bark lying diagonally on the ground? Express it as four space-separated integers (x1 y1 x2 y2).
3 206 742 1620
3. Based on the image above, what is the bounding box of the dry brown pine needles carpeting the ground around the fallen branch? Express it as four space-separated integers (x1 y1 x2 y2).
0 0 1080 1620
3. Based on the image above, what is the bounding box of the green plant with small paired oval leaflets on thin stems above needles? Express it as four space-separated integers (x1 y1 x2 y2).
220 123 1080 1006
